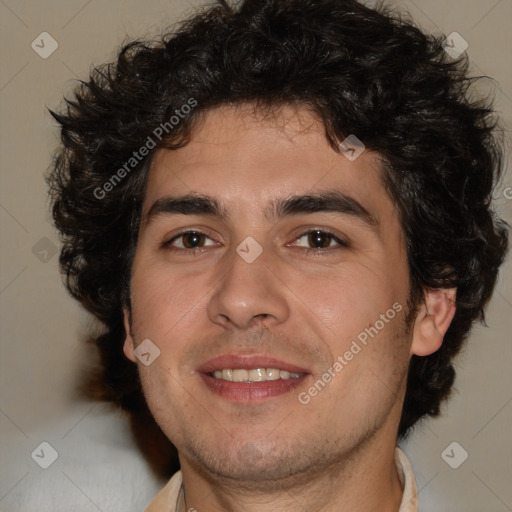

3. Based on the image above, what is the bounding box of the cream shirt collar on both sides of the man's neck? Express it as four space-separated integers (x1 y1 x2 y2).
145 447 418 512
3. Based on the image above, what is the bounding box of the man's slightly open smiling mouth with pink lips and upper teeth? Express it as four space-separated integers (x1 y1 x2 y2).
197 355 310 402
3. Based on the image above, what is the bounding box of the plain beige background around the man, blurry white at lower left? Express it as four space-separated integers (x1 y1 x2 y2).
0 0 512 512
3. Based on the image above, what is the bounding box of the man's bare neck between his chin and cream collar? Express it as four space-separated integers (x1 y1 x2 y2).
181 424 403 512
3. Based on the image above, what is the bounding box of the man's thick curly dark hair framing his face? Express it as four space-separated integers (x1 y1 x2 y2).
47 0 508 474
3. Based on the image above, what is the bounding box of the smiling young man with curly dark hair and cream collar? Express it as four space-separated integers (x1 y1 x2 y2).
49 0 507 512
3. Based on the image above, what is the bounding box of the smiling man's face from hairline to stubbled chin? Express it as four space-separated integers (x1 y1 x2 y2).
125 103 411 481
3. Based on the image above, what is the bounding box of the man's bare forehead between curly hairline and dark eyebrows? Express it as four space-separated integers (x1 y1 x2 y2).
145 105 394 225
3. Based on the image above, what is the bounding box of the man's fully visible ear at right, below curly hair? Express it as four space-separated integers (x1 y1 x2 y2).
411 288 457 356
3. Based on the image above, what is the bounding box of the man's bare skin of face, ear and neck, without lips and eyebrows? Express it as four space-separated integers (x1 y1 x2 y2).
124 105 455 512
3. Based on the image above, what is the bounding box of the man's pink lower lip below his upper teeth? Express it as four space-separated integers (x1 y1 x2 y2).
199 373 307 402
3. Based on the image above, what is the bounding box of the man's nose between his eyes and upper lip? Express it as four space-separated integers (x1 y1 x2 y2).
208 246 290 329
